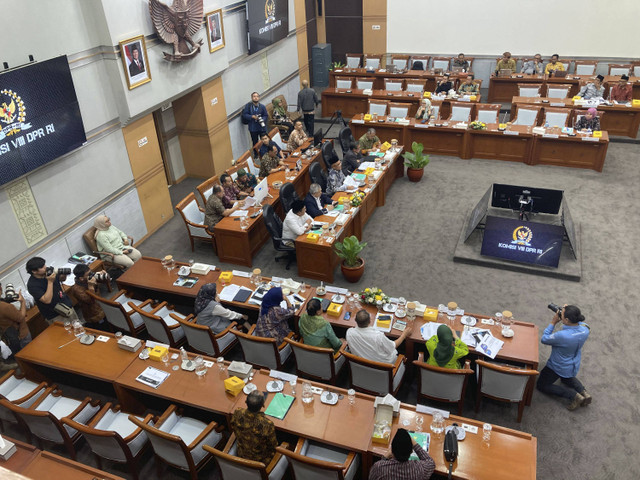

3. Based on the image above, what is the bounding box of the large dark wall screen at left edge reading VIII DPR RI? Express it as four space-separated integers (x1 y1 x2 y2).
0 56 87 185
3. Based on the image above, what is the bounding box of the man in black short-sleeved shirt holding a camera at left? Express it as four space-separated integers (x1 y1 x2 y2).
27 257 78 324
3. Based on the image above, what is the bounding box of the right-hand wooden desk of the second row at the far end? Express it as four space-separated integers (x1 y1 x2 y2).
511 97 640 138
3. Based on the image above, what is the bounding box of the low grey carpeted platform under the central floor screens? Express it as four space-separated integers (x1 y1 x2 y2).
453 207 582 282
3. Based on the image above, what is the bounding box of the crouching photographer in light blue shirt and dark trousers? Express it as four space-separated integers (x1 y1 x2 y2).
537 303 591 410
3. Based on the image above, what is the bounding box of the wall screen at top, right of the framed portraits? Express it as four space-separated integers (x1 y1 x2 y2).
247 0 289 55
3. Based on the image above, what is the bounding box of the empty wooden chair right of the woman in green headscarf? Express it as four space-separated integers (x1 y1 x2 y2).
476 360 538 423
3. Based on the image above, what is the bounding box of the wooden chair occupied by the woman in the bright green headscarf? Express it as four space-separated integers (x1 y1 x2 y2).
413 352 473 415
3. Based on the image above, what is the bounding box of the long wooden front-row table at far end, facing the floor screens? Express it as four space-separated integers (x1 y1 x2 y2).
350 114 609 172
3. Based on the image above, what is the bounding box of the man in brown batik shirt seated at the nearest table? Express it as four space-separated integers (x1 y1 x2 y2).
229 390 278 465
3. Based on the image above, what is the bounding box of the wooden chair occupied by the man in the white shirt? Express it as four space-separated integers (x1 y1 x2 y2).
342 349 407 396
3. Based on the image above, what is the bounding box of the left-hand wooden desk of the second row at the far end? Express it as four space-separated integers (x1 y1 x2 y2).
322 87 482 122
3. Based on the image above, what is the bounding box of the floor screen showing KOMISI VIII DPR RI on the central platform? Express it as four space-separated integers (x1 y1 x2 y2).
480 215 564 267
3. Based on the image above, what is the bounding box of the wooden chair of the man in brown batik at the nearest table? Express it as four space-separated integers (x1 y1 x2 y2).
202 433 289 480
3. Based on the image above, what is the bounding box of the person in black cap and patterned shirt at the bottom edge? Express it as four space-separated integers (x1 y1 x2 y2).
369 428 436 480
